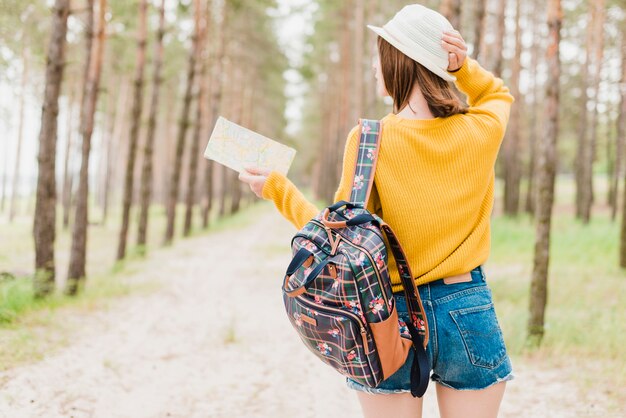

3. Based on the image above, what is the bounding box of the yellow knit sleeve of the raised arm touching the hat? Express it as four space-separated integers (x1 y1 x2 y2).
449 57 515 145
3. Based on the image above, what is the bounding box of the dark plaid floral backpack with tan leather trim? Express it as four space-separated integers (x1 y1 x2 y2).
282 119 430 397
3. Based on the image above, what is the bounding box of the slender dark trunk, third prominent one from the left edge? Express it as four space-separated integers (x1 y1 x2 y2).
117 0 148 260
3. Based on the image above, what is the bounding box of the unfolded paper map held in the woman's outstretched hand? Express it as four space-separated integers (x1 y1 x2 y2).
204 116 296 175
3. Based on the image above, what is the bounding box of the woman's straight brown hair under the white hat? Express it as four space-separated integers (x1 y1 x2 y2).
378 36 467 118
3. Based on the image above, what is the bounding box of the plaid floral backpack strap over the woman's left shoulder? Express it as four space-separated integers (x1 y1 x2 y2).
350 119 382 208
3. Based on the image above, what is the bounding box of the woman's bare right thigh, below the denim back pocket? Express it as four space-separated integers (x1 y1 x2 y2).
437 382 506 418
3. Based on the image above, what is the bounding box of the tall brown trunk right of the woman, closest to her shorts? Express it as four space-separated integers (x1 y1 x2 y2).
528 0 563 345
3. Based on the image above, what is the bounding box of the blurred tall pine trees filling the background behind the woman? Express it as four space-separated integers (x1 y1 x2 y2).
0 0 626 346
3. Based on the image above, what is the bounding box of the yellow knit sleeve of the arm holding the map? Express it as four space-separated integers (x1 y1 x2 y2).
261 125 359 229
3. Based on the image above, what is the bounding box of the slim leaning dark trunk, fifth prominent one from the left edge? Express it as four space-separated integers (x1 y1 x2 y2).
165 0 200 245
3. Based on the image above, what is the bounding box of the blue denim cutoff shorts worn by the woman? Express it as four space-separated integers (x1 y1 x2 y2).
346 266 513 394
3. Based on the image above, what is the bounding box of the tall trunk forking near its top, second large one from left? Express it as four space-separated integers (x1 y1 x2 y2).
65 0 106 295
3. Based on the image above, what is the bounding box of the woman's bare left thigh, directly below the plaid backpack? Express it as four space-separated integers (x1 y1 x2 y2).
357 392 422 418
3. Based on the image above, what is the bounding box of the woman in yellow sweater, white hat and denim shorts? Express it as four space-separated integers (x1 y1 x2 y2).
239 5 514 418
